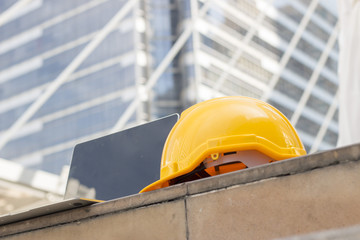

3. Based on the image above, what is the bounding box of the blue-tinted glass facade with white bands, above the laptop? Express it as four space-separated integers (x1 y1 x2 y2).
0 0 136 174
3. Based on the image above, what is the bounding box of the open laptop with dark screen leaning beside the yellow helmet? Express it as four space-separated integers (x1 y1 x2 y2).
0 114 179 225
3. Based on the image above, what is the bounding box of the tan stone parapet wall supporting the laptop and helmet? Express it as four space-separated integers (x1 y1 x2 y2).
0 145 360 240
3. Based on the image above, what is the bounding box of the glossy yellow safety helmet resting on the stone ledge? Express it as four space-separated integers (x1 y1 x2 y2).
141 96 306 192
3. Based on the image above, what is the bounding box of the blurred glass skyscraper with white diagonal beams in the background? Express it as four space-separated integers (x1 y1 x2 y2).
0 0 338 213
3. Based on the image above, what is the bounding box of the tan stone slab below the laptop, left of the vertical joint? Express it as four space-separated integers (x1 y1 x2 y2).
5 200 186 240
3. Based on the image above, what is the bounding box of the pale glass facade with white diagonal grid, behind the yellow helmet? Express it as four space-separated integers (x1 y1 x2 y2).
187 0 338 152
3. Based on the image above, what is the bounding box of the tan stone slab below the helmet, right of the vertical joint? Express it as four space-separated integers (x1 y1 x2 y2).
186 161 360 239
